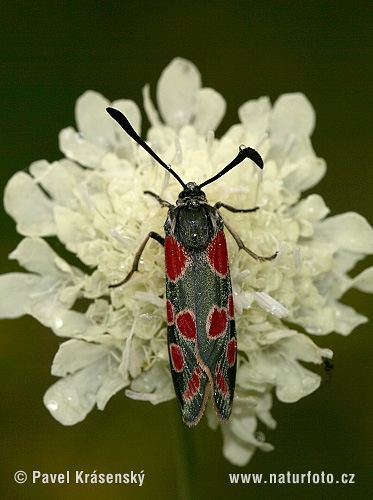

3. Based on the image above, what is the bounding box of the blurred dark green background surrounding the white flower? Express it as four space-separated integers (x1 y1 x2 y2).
0 0 372 500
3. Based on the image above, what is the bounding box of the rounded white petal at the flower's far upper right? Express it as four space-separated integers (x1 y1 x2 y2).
270 93 316 150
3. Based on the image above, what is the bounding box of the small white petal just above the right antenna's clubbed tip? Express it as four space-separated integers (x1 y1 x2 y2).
238 97 271 142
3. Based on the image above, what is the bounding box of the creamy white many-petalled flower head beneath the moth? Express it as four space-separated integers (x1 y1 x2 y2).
0 59 373 465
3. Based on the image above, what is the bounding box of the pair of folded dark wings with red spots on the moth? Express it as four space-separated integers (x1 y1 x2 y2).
165 225 236 425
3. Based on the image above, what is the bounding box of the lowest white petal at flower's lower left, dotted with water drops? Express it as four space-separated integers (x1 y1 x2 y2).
43 354 108 425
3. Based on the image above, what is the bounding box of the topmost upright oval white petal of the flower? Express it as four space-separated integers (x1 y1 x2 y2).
157 57 201 129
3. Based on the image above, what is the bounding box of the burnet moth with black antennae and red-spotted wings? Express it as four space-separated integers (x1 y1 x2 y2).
107 108 277 426
